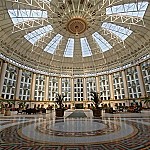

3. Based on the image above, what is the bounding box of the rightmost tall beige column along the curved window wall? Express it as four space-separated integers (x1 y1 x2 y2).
136 65 146 97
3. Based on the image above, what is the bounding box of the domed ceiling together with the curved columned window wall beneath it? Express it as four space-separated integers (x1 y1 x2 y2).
0 0 150 108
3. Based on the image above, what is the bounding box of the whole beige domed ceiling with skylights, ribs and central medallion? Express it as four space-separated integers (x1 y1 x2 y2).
0 0 150 74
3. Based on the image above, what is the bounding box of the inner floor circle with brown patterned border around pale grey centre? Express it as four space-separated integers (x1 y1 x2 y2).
36 119 120 137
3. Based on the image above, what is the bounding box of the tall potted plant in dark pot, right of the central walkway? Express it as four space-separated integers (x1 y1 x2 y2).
90 90 102 117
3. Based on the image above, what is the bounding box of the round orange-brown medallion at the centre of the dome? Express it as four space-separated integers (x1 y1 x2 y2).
67 18 87 35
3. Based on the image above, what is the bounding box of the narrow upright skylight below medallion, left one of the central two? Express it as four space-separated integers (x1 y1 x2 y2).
64 38 74 57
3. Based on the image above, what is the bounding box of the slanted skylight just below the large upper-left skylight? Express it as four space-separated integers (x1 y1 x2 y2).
24 25 53 44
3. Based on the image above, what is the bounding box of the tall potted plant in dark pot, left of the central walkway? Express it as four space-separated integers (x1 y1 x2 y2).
55 94 65 117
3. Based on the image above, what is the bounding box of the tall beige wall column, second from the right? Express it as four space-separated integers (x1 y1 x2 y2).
121 70 129 99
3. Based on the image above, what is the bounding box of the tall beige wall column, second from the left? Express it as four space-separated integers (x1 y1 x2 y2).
15 68 22 100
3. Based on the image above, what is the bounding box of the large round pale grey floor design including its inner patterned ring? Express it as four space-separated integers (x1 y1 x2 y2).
18 119 137 145
